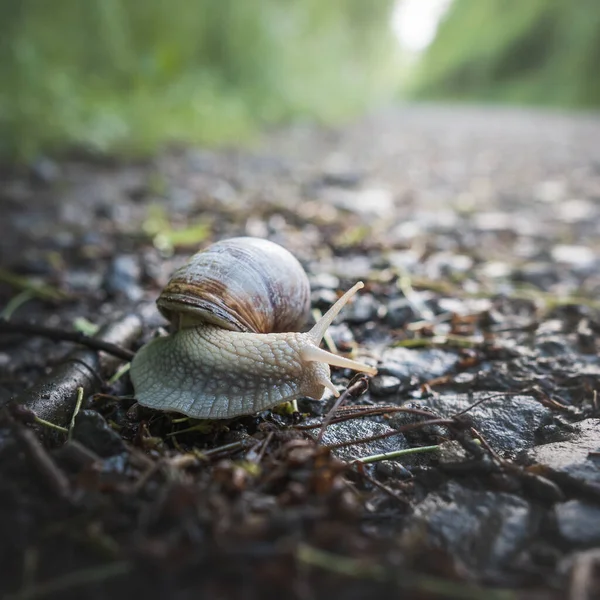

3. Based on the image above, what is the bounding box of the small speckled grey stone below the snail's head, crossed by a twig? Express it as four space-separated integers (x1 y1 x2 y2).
307 419 408 462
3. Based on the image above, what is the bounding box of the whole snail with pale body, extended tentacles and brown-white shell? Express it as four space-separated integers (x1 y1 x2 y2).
131 237 377 419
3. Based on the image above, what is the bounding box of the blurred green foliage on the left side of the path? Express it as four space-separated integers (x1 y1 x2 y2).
0 0 394 159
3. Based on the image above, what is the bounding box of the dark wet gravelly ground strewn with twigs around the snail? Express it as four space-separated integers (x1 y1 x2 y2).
0 106 600 600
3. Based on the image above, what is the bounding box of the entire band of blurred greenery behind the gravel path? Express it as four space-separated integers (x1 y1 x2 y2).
0 0 600 160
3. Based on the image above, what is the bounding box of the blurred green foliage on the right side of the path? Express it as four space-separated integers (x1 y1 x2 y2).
414 0 600 108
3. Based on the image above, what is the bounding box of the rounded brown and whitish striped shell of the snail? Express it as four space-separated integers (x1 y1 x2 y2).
157 237 310 333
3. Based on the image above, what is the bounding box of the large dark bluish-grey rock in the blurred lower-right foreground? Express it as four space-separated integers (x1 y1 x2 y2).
403 481 539 579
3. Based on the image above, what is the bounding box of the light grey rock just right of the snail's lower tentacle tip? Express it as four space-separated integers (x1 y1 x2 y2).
379 348 458 387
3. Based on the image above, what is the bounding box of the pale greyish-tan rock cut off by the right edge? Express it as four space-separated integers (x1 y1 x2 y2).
523 419 600 492
